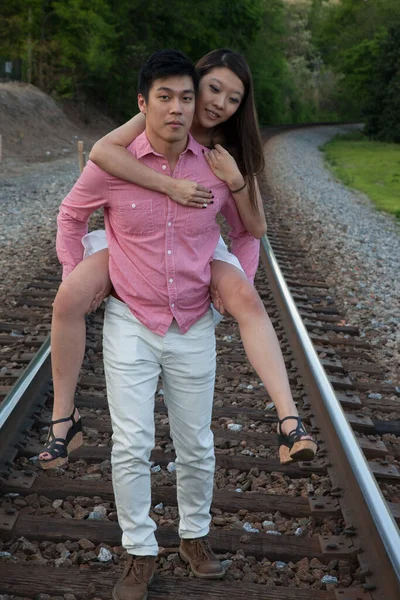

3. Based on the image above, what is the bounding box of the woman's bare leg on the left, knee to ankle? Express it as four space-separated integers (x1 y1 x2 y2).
39 249 111 460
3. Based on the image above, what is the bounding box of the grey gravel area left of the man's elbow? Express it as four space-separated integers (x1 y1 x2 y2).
0 157 79 307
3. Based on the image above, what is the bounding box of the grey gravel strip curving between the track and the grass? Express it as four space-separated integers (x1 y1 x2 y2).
265 126 400 385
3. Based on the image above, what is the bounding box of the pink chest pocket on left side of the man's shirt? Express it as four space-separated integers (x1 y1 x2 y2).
116 191 155 236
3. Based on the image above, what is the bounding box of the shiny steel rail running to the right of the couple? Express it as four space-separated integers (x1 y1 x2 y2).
261 235 400 600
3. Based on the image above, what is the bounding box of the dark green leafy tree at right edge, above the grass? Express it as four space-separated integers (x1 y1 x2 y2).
310 0 400 142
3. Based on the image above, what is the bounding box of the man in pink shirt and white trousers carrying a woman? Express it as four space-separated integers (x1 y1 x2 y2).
57 50 258 600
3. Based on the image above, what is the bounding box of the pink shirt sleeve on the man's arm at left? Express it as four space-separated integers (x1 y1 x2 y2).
56 161 109 279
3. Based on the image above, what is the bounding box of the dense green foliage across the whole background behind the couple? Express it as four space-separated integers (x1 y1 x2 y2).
0 0 400 136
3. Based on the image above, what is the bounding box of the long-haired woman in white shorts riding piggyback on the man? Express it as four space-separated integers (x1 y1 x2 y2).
39 50 317 469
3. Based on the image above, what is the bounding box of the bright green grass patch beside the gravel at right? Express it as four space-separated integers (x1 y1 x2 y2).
320 131 400 218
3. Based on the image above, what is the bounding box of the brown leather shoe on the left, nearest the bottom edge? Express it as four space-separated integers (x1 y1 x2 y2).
113 554 156 600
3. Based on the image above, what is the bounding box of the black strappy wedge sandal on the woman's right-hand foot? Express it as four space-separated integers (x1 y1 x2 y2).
278 417 318 465
